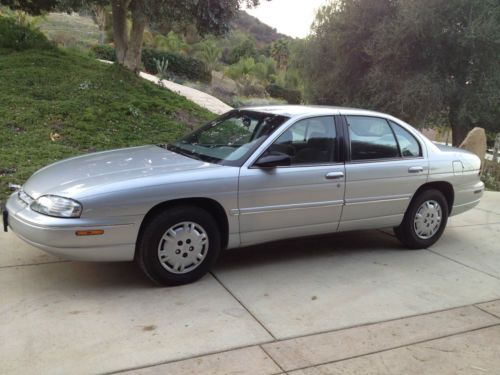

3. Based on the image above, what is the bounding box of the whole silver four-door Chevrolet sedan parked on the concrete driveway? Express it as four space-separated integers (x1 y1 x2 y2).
3 106 484 285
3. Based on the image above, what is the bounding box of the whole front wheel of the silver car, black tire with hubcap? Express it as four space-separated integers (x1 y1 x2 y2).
136 206 221 286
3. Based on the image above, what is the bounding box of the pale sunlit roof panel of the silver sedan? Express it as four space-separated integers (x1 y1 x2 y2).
240 105 389 118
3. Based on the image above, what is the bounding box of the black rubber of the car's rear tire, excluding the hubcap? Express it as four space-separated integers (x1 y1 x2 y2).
395 189 449 249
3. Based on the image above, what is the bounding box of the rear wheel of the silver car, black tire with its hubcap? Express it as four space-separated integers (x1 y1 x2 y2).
394 189 449 249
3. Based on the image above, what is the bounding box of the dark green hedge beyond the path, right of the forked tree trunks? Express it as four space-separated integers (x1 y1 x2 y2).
142 48 212 82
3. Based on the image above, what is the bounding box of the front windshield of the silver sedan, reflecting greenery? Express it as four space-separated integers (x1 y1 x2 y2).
167 110 288 166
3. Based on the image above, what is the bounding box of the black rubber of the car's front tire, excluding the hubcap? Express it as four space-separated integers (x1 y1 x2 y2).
136 206 221 286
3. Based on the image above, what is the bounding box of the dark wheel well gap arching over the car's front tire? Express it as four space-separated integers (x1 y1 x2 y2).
139 198 229 249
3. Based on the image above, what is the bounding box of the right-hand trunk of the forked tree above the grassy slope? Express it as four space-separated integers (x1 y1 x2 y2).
123 0 146 72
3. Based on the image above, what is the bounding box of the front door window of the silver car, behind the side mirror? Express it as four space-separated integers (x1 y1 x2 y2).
268 116 337 165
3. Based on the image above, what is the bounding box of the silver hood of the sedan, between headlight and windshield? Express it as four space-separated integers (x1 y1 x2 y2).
23 146 220 199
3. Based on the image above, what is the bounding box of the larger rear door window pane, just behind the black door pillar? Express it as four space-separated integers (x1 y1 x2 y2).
346 116 399 160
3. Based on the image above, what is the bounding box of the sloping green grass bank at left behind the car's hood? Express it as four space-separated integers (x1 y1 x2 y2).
0 48 215 206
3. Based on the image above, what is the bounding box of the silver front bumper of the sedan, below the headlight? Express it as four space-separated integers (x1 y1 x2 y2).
6 194 142 262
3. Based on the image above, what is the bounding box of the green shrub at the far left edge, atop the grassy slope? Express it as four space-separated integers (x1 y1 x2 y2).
0 17 53 51
